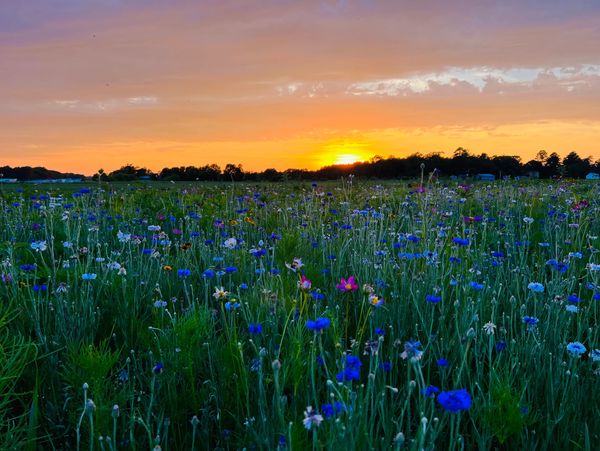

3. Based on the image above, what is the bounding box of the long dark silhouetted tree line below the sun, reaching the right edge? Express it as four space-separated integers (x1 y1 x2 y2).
94 147 600 182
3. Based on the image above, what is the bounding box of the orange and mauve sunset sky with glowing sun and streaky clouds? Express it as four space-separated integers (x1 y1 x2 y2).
0 0 600 175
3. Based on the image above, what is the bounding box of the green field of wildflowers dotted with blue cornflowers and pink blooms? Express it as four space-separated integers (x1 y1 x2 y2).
0 180 600 450
